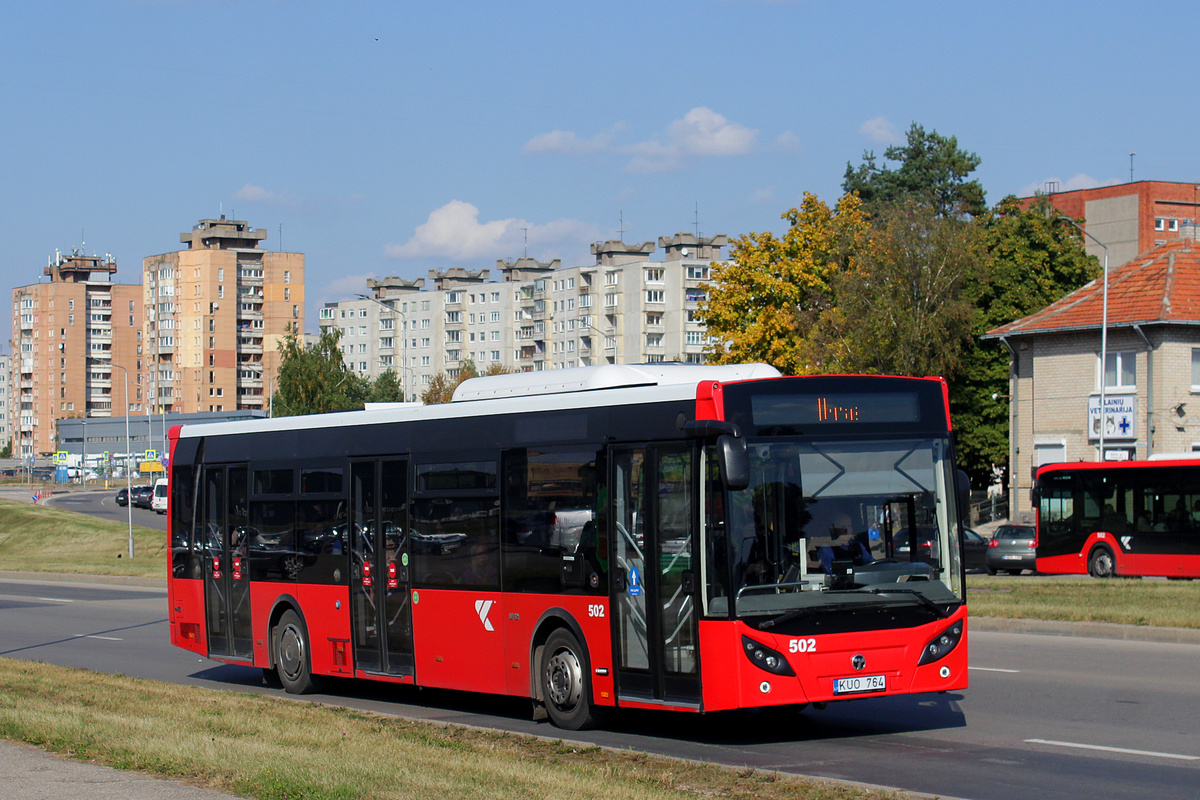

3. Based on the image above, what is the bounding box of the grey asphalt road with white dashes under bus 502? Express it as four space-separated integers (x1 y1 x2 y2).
0 575 1200 800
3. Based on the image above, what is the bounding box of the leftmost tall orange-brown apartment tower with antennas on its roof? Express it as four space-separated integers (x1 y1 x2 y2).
10 251 142 458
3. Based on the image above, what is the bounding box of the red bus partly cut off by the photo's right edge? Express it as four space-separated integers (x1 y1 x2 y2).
1033 458 1200 578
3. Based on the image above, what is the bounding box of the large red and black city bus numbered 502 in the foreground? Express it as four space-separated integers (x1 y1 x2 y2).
168 365 967 729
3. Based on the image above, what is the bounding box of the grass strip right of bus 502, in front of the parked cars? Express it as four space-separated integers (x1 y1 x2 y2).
967 575 1200 627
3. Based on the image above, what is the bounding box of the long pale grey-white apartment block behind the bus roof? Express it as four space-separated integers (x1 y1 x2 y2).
319 234 727 396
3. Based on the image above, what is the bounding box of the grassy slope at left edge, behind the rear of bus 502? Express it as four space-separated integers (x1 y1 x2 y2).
0 500 167 578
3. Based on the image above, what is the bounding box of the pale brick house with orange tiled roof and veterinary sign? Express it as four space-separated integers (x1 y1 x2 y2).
984 239 1200 518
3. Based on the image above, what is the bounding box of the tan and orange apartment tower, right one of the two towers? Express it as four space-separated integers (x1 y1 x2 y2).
139 215 304 413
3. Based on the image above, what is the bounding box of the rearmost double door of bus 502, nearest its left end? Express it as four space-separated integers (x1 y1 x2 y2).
198 464 254 660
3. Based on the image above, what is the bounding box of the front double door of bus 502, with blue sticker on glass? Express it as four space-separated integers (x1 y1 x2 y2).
611 445 701 706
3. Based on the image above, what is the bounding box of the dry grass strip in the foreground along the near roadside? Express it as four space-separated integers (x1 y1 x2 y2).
0 660 902 800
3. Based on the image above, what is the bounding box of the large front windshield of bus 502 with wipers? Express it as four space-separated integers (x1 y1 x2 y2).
706 438 962 618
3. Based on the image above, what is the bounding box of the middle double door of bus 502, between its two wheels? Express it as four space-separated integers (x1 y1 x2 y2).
349 458 413 675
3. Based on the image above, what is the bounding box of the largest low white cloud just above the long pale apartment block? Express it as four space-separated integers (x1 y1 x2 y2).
384 200 599 260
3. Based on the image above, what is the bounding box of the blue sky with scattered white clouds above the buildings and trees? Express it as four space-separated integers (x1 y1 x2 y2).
0 0 1200 350
